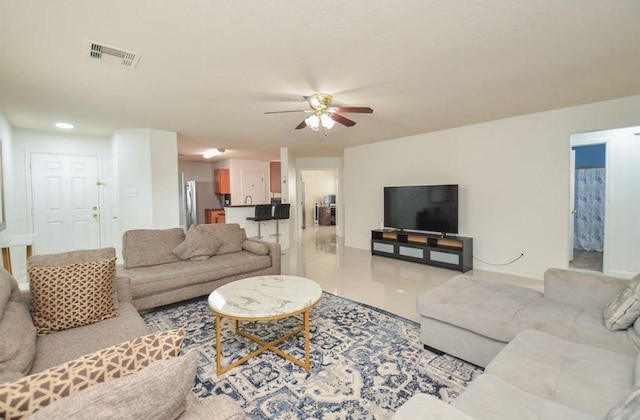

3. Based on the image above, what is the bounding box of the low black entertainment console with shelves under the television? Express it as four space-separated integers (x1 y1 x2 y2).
371 229 473 273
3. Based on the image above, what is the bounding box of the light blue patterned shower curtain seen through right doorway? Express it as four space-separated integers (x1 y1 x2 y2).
574 168 605 252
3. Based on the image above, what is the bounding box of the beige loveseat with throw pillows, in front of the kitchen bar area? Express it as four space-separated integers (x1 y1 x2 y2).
118 224 281 310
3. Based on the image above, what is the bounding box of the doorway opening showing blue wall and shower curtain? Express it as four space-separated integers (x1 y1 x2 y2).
569 143 607 271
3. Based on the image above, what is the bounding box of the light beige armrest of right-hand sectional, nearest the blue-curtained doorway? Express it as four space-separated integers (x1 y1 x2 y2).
544 268 629 309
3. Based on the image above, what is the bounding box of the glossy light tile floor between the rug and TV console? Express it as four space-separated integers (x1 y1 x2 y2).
282 226 542 321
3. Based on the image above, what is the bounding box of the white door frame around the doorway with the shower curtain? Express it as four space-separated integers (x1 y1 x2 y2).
567 135 612 274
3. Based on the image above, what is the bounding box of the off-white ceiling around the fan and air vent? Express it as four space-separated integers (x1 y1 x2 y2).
0 0 640 160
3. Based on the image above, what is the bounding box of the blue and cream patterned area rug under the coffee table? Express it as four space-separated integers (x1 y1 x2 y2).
143 293 482 419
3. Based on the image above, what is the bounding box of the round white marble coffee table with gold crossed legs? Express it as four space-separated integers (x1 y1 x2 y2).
209 275 322 375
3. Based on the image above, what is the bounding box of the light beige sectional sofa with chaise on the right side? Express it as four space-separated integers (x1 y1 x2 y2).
394 269 640 420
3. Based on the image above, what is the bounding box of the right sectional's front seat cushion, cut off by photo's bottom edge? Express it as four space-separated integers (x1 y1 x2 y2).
451 373 600 420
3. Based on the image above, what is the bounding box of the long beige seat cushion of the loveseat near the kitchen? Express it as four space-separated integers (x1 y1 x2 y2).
120 251 271 298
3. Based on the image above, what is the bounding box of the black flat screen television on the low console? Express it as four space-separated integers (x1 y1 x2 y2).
384 185 458 234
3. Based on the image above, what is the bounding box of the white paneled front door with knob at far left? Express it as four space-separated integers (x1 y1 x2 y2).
31 153 101 254
